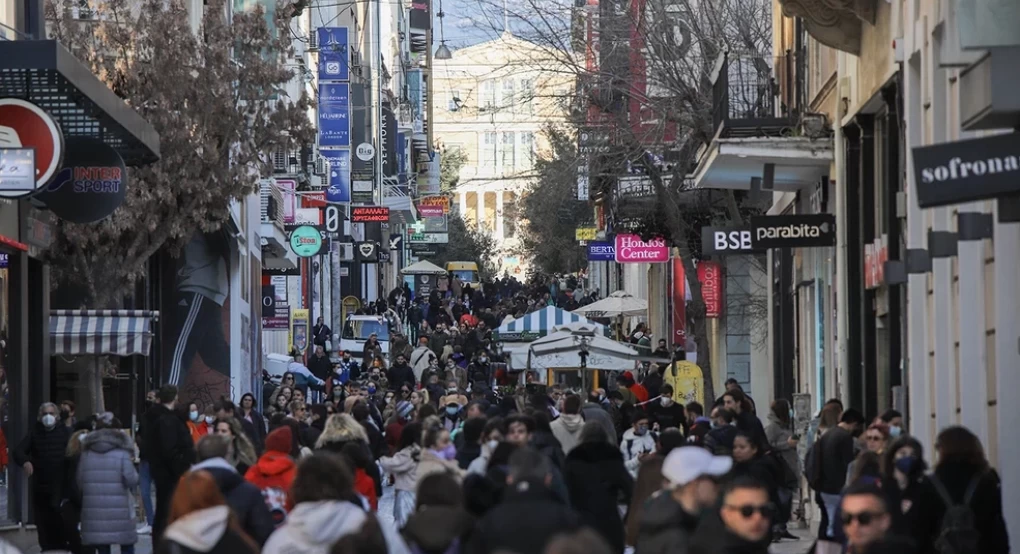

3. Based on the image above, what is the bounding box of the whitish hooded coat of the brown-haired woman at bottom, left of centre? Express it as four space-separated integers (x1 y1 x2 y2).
262 500 409 554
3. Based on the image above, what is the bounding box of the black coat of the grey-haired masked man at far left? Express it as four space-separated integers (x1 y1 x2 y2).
13 421 70 508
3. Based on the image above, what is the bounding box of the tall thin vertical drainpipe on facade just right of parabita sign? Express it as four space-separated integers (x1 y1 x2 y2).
832 54 850 402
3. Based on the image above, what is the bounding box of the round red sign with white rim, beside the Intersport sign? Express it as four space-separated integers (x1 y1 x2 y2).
0 98 63 196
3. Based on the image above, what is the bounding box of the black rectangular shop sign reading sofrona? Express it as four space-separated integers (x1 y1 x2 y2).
913 133 1020 208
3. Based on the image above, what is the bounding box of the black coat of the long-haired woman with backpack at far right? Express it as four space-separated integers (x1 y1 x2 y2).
913 461 1010 554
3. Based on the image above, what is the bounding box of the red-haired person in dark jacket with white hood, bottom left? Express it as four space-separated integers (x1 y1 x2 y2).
155 470 259 554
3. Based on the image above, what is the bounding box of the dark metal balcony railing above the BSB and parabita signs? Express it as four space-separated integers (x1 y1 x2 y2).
712 52 793 137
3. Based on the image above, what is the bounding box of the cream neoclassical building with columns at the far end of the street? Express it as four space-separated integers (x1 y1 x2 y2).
432 33 574 276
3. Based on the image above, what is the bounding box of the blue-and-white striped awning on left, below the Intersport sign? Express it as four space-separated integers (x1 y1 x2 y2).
50 310 159 356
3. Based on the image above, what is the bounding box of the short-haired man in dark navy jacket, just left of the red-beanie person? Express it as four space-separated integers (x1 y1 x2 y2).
192 435 275 546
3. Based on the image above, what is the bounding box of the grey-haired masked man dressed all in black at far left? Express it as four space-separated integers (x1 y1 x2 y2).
12 402 70 552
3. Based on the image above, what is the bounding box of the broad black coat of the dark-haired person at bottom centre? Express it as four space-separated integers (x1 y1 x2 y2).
466 482 583 554
